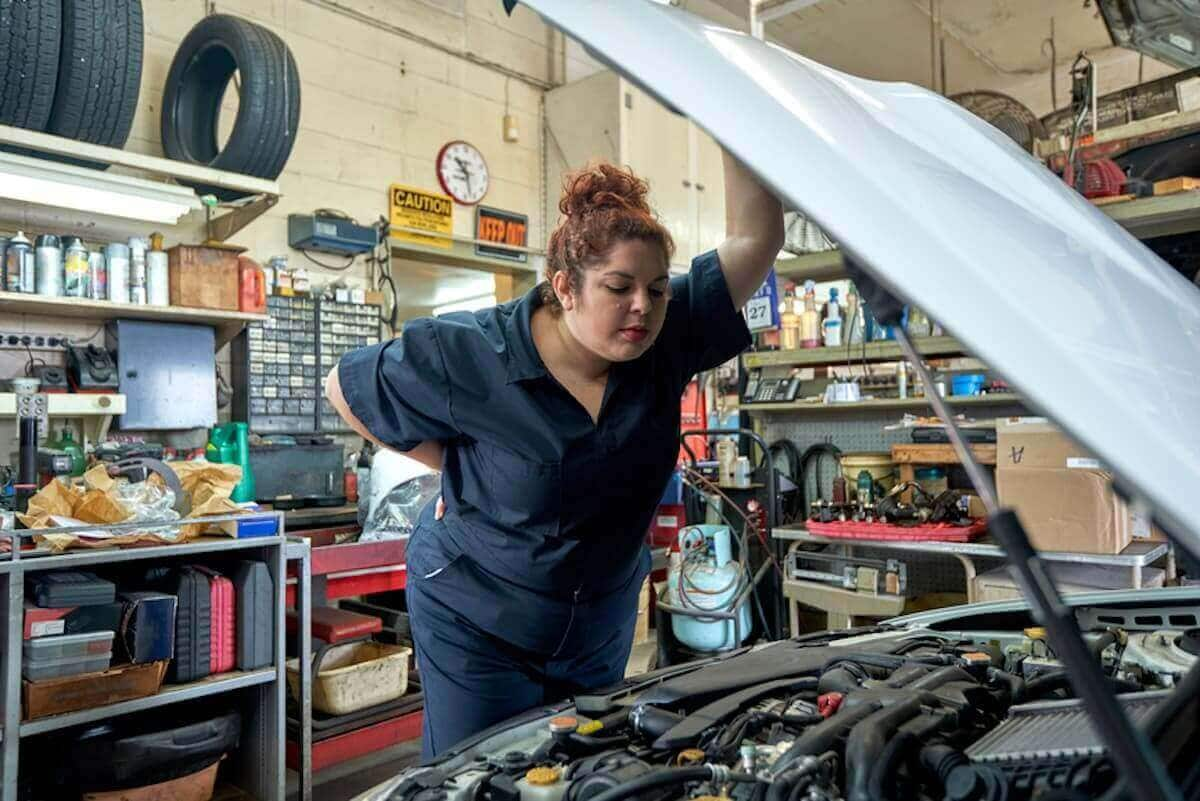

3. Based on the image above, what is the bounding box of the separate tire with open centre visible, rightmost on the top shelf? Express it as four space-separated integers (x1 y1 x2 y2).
162 14 300 200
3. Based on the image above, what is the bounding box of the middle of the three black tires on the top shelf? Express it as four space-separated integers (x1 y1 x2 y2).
46 0 143 169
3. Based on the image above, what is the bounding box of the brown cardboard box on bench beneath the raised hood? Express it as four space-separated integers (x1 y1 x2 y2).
996 417 1162 554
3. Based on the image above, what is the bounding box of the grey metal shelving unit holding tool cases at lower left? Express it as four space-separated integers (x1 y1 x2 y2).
0 512 308 801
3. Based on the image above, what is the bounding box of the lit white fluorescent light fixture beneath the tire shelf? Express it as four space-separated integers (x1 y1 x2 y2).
0 153 200 225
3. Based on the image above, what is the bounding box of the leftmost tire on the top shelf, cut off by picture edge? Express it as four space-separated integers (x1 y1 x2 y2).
0 0 62 133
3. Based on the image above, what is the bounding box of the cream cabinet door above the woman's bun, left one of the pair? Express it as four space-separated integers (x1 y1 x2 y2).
620 80 696 264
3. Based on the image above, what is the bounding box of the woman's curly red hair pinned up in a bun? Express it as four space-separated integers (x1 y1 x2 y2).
541 162 674 309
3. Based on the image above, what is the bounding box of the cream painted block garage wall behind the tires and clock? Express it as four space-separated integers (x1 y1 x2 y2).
0 0 563 438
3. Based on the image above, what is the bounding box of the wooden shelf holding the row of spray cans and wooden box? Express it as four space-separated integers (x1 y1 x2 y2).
0 293 268 348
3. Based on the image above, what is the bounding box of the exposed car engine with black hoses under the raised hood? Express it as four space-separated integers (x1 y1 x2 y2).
370 626 1200 801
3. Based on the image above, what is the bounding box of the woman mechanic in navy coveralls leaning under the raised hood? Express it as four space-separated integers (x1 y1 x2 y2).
325 155 784 759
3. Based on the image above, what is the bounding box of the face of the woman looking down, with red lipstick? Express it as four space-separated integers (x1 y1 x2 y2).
553 240 670 362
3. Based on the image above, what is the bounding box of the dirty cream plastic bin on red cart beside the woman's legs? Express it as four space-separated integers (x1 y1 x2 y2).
288 642 413 715
